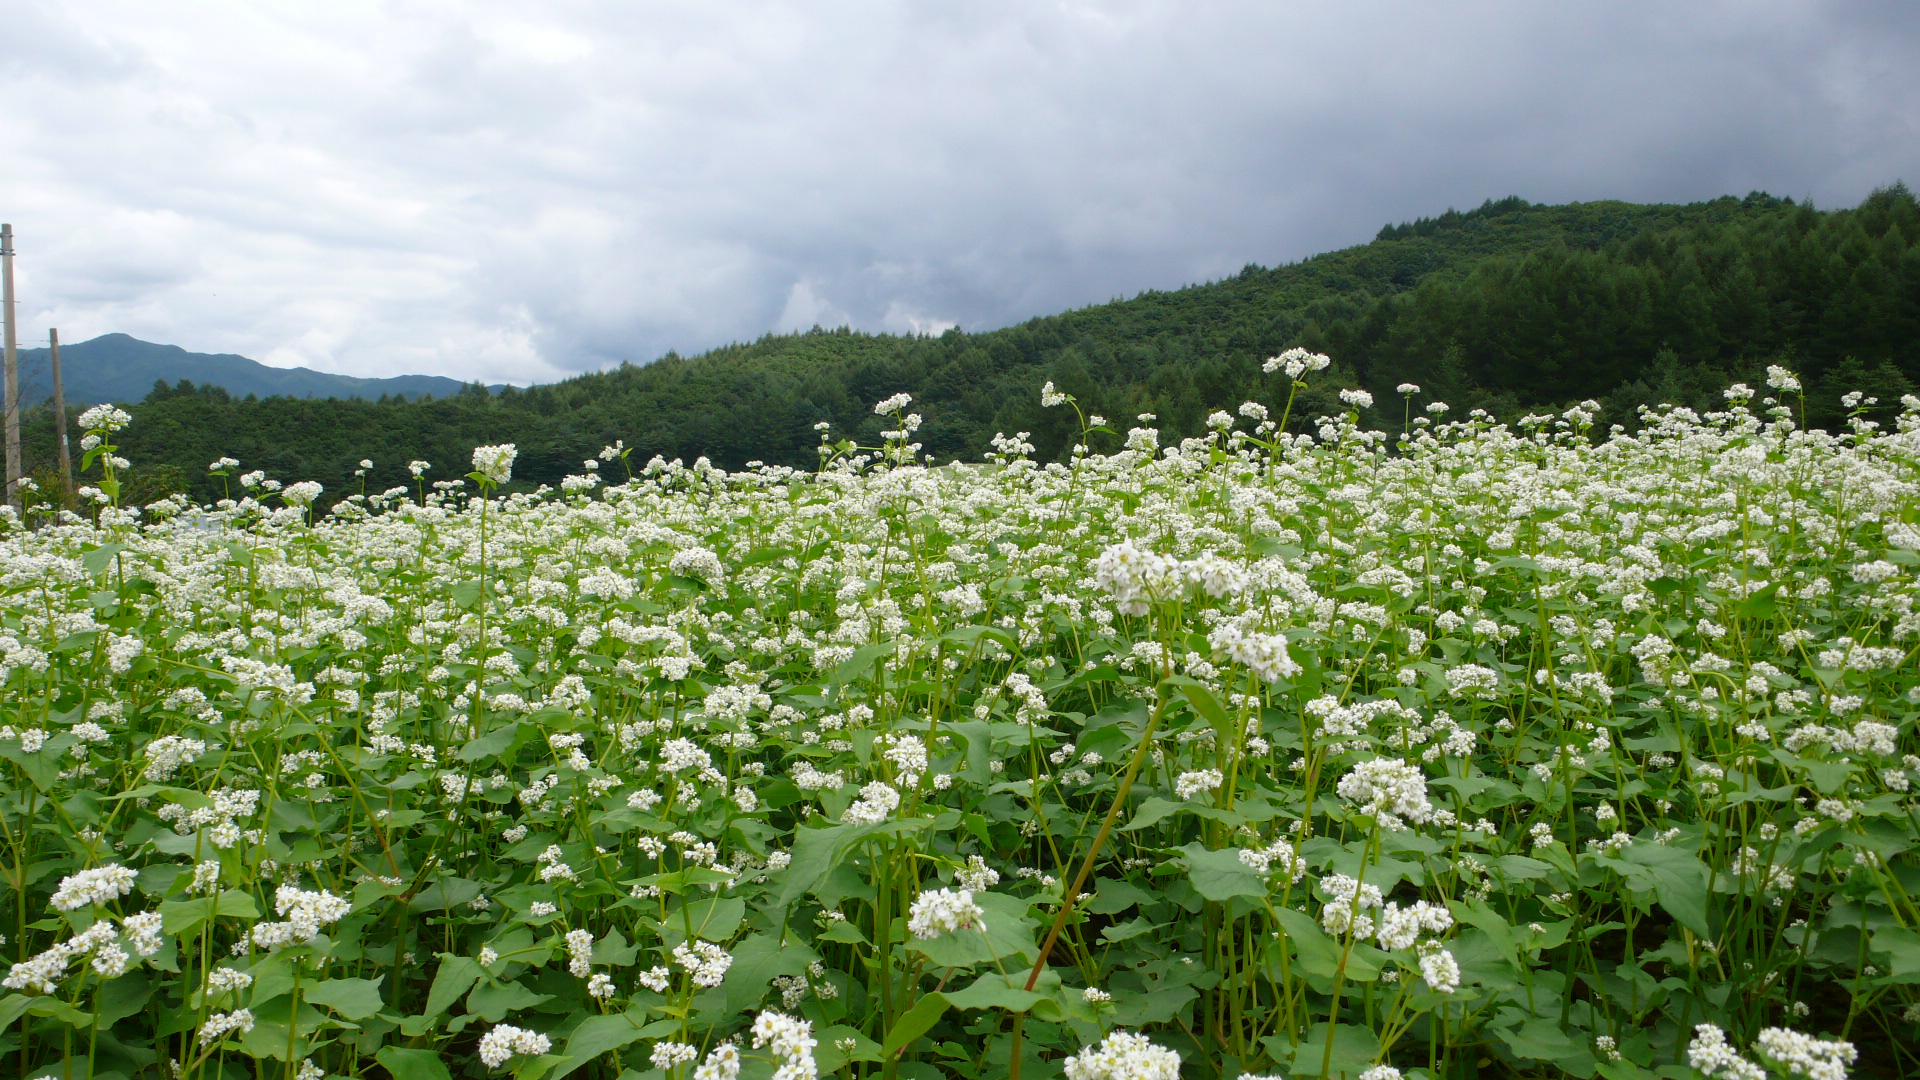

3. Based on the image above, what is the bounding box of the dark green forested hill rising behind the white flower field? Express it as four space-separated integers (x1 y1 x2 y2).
18 184 1920 496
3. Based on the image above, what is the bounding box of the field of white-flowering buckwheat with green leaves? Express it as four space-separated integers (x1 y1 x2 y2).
0 350 1920 1080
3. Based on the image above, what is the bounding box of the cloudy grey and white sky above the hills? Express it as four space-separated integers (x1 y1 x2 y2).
0 0 1920 382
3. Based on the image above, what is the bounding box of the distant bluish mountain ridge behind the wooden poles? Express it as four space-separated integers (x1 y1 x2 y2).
19 334 487 405
